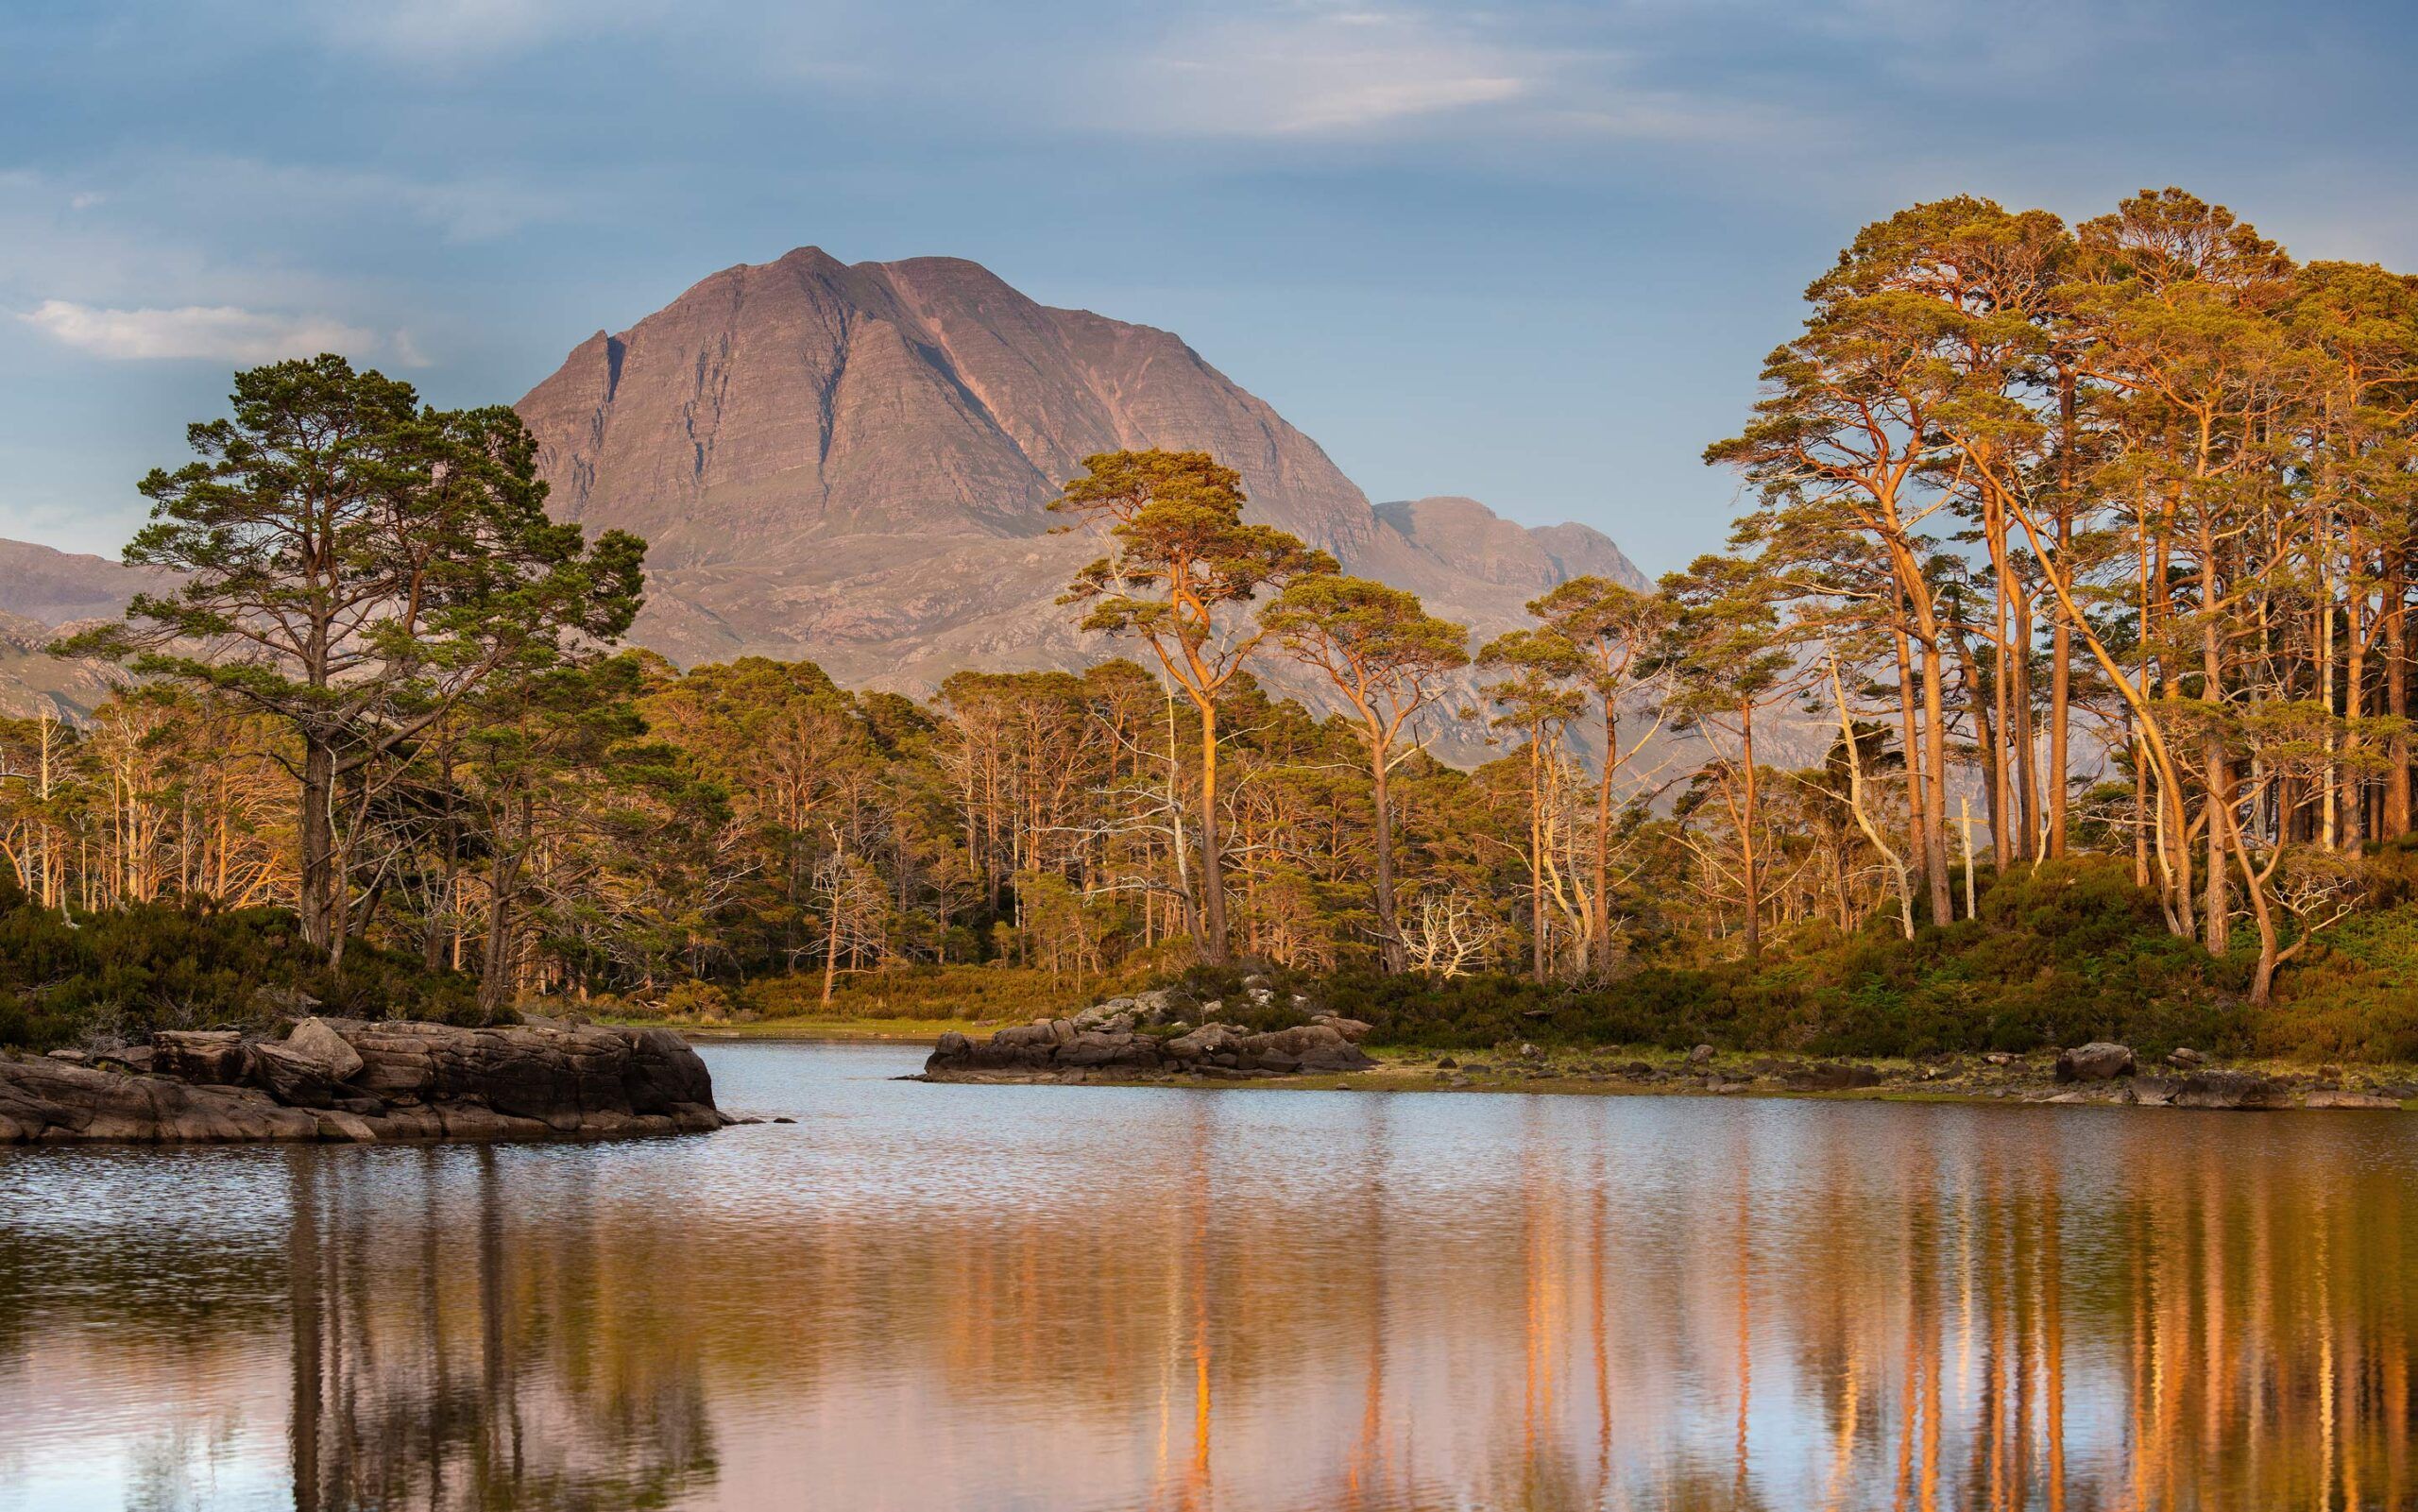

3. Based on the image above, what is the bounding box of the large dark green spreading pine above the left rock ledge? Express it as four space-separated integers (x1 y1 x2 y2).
60 356 646 960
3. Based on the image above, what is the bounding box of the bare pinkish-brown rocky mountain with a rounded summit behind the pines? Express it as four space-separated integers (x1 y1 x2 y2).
519 246 1642 692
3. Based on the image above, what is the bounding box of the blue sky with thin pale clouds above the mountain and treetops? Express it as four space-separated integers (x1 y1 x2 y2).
0 0 2418 571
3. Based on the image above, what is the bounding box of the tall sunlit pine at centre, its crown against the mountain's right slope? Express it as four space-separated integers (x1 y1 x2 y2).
1049 450 1335 965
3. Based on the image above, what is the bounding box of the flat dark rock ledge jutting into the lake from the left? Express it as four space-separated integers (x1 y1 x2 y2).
0 1018 738 1145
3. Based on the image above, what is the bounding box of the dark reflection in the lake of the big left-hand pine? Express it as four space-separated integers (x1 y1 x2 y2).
288 1149 716 1512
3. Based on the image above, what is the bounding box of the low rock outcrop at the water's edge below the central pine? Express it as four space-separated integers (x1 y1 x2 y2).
924 992 1376 1081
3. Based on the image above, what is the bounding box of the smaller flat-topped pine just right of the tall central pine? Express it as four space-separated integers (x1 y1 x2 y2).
1260 576 1470 973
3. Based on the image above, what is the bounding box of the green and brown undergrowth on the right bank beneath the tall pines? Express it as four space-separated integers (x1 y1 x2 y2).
1201 858 2418 1062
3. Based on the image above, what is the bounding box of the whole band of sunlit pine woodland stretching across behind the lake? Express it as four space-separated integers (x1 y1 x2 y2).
14 189 2418 1030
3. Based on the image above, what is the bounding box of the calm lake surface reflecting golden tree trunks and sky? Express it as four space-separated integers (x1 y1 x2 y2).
0 1045 2418 1512
